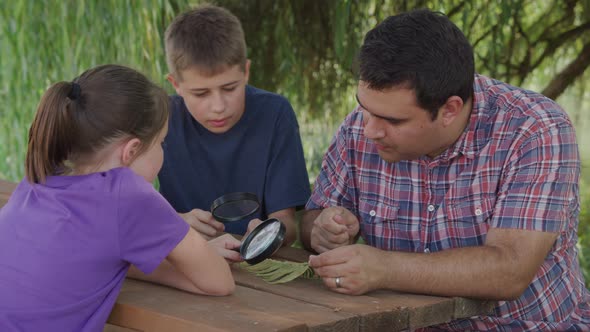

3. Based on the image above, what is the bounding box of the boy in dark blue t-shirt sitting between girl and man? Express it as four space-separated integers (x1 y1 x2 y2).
158 5 310 244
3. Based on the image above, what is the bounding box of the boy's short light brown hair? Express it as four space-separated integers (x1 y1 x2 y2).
165 4 247 80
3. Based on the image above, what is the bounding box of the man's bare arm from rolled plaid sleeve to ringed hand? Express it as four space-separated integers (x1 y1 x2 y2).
309 228 558 301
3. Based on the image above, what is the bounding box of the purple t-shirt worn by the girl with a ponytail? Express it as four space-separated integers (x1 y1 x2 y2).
0 168 189 331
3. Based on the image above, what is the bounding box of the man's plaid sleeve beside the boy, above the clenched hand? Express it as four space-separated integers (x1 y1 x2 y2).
305 116 357 212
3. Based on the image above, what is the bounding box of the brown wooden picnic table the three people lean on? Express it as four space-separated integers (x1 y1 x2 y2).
0 180 494 332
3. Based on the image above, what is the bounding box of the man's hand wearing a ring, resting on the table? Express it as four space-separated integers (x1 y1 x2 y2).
309 244 386 295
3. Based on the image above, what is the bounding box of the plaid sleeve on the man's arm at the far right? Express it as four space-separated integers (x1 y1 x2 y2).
490 124 580 232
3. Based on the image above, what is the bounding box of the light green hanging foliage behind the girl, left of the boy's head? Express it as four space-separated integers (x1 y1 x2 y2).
0 0 182 180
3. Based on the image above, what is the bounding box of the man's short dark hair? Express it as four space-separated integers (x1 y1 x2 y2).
358 9 475 119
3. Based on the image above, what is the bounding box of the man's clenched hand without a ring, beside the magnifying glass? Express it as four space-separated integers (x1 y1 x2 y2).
311 207 359 253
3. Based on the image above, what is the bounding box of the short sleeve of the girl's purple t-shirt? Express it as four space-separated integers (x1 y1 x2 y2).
118 188 189 274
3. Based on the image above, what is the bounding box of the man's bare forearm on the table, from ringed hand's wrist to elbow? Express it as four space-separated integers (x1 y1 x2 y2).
375 246 534 300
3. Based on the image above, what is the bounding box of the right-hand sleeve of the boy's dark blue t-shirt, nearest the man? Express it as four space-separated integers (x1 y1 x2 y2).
264 100 310 213
